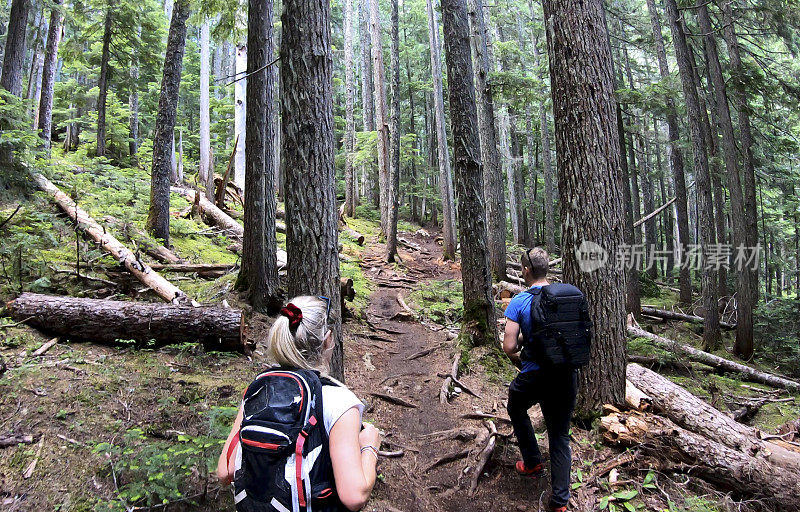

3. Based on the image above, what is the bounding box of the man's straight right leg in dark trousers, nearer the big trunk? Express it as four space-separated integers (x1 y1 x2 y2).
540 372 577 507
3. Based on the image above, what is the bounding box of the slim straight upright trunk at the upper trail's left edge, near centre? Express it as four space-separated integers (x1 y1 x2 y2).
386 0 400 262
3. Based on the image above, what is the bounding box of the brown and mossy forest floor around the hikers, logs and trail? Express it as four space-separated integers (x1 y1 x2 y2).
0 167 800 512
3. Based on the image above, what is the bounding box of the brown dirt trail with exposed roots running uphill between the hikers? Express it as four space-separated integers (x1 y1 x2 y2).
338 232 547 512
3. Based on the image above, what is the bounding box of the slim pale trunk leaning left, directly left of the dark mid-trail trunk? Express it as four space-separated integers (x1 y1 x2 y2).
424 0 456 260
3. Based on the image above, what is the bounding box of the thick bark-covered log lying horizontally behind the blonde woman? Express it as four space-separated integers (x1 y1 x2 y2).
6 293 244 350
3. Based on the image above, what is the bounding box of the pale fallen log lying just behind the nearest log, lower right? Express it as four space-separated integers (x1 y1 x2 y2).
626 364 800 472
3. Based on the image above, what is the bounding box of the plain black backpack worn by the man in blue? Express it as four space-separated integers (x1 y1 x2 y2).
522 283 592 369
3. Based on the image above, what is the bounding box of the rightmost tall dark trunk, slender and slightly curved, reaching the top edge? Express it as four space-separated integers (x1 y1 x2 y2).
722 2 758 307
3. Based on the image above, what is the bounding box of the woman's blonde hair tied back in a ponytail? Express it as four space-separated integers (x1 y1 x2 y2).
267 295 328 372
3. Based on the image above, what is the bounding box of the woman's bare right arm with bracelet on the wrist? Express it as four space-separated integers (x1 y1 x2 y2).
329 407 380 511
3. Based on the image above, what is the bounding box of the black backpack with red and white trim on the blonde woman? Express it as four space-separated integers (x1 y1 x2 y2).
231 368 345 512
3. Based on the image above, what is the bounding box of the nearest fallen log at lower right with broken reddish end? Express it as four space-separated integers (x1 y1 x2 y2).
600 412 800 512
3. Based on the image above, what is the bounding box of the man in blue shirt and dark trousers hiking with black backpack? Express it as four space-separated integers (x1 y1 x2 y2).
503 247 591 512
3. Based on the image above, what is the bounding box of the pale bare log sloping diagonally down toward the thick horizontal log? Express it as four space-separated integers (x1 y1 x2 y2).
30 171 189 304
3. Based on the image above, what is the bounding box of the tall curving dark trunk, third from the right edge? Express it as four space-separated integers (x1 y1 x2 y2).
665 0 721 350
